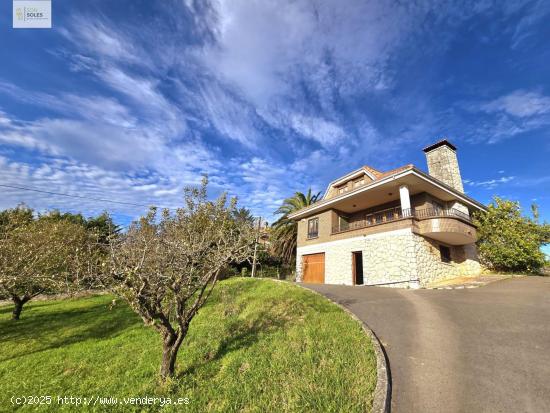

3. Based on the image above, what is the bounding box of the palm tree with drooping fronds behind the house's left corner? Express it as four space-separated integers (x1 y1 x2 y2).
272 188 321 264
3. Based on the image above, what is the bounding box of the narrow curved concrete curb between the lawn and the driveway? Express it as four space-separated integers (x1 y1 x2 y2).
280 280 391 413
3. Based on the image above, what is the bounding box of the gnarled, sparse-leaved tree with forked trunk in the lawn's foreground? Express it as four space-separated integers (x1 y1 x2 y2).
105 178 254 380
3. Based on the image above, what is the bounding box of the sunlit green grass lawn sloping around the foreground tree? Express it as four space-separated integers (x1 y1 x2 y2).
0 278 376 412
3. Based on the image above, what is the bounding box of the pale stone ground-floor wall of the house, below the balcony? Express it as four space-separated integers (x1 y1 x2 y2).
296 227 481 288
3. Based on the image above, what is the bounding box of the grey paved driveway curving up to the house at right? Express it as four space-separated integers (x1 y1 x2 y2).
308 277 550 413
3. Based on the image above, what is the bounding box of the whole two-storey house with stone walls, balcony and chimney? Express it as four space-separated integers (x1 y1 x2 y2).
290 140 486 288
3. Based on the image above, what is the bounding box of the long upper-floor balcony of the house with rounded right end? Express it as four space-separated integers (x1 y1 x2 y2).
332 207 476 245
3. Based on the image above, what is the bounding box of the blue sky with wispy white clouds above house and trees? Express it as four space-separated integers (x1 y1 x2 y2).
0 0 550 241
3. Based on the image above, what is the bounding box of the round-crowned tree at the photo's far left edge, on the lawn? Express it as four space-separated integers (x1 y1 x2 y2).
0 208 99 320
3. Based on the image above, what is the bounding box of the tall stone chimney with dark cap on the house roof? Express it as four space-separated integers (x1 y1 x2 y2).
424 139 464 192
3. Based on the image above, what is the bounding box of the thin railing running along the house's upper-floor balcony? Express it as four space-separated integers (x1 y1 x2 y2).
332 207 471 234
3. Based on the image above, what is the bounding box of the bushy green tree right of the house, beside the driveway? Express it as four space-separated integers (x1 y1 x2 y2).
475 197 549 273
